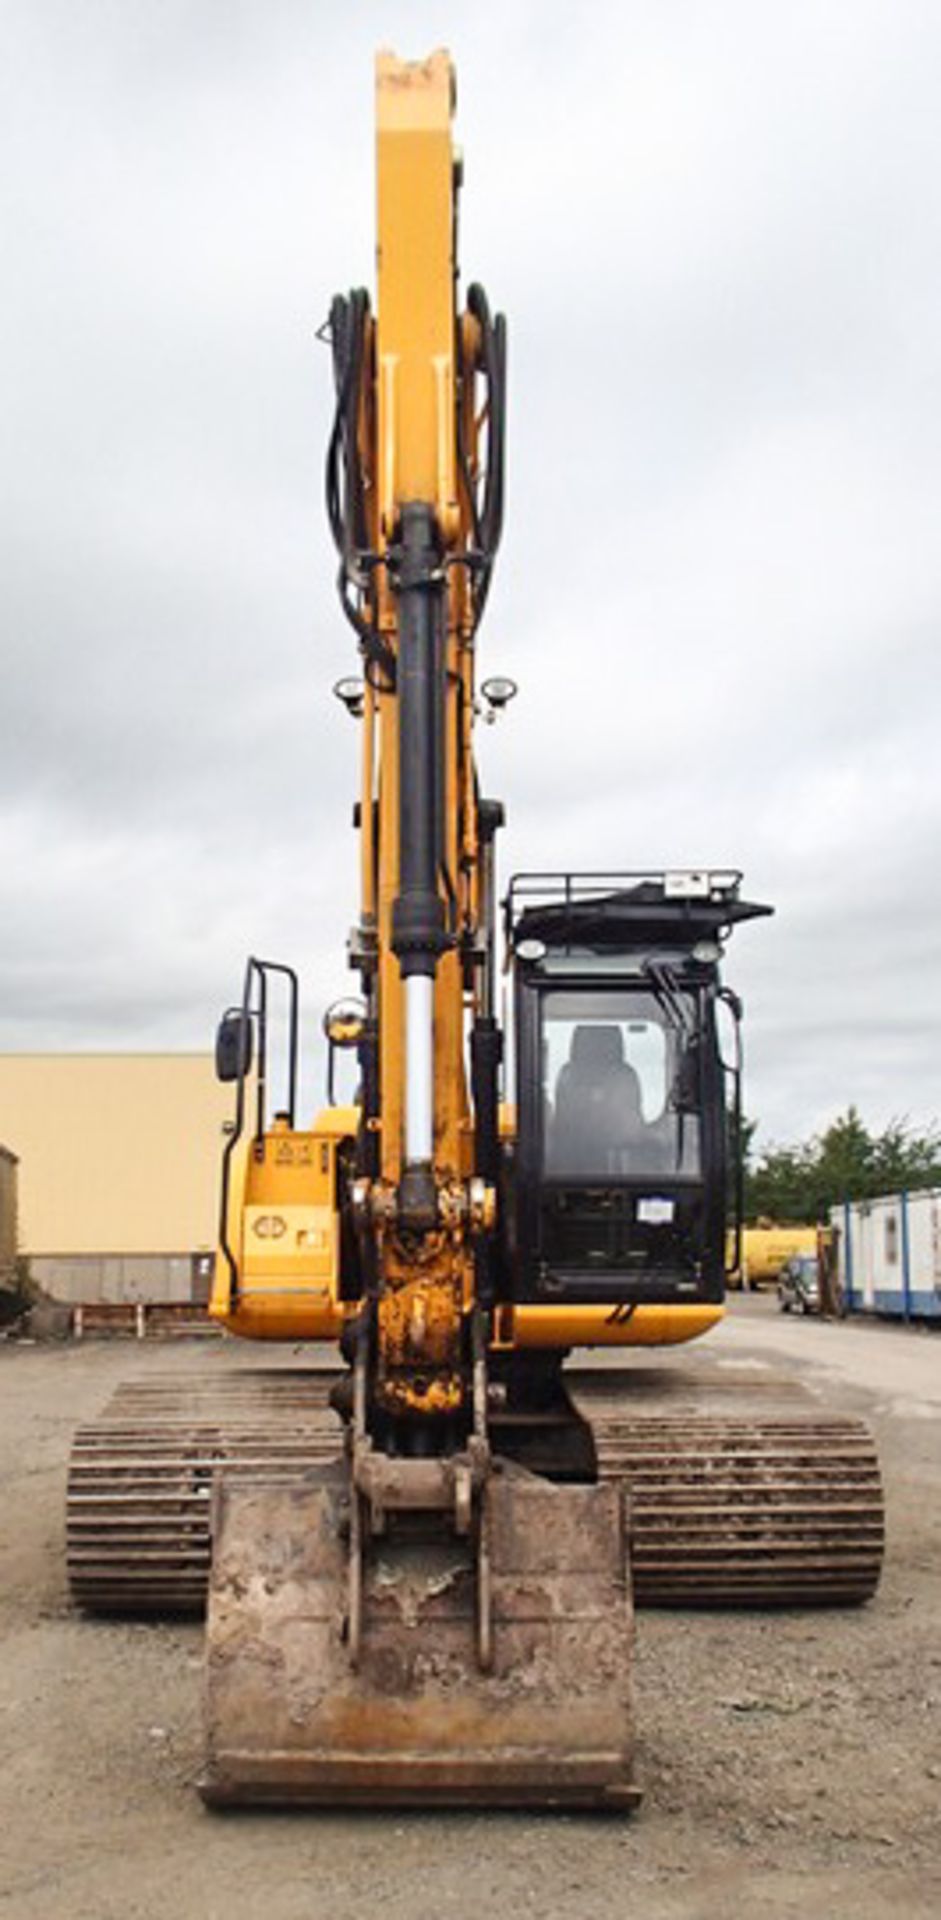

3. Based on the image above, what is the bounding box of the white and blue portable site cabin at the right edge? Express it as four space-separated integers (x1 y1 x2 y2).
830 1187 941 1319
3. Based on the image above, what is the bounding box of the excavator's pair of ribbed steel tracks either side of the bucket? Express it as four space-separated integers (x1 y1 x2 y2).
67 1369 883 1613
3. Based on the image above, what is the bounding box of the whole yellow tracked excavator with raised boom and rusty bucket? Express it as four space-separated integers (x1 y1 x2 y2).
69 52 881 1807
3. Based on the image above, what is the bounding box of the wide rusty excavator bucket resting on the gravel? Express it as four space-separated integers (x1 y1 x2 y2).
202 1463 639 1807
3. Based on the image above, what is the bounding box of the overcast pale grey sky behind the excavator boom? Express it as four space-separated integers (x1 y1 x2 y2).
0 0 941 1139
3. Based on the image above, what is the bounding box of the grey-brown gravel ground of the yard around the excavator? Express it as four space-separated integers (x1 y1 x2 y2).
0 1296 941 1920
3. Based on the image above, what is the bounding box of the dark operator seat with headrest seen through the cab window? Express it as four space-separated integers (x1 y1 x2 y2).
547 1023 643 1179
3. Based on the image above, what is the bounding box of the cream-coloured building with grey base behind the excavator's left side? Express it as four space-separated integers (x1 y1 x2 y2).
0 1054 232 1302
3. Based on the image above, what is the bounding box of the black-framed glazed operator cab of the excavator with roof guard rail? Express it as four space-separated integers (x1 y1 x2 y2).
507 872 770 1308
